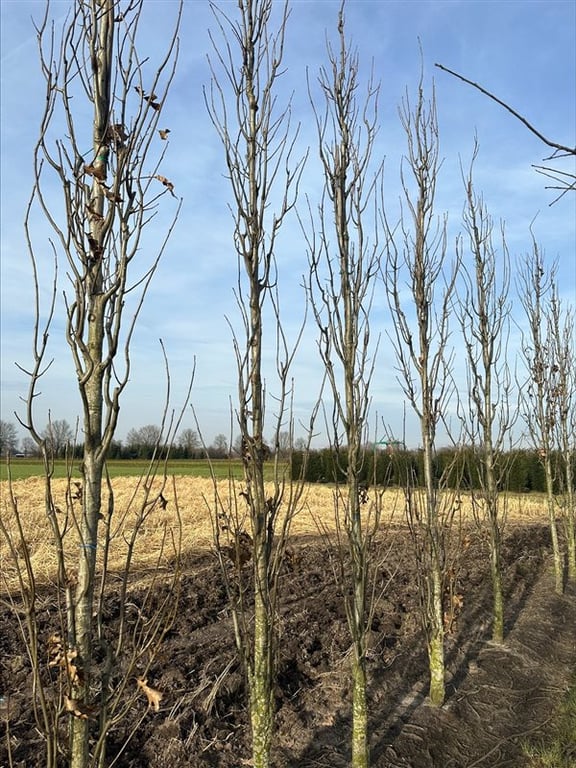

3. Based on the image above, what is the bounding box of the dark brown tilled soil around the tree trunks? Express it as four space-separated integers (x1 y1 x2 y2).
0 525 576 768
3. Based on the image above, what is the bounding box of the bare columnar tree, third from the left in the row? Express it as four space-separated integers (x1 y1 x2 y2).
307 6 382 768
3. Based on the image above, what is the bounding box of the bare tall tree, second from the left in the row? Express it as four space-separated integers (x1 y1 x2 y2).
206 0 310 768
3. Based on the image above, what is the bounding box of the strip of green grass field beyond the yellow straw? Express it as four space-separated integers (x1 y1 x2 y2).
0 458 256 480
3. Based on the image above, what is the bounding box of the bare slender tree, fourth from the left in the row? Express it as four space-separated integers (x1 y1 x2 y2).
385 78 459 705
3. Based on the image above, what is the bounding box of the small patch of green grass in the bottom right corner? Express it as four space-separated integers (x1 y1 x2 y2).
524 675 576 768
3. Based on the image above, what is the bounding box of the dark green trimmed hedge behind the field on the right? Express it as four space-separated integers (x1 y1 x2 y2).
291 448 576 493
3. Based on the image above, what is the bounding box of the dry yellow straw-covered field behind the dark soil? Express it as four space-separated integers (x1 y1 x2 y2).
0 477 546 591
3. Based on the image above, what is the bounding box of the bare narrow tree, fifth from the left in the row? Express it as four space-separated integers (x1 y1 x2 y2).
457 145 515 643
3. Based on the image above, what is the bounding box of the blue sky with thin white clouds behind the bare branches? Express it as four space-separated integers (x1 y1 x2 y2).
0 0 576 445
